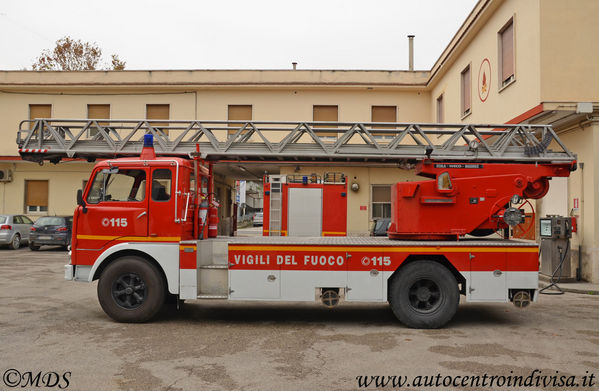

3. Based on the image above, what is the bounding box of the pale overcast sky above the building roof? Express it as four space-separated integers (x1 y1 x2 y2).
0 0 477 70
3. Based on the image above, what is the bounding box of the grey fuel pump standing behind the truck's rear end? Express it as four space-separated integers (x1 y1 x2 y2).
539 215 572 278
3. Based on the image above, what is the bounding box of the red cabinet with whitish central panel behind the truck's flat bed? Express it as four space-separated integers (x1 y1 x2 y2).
262 173 347 236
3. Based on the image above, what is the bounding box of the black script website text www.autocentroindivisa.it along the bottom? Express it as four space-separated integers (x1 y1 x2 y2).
356 369 597 391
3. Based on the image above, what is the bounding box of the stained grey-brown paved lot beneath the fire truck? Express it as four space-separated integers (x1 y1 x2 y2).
0 248 599 390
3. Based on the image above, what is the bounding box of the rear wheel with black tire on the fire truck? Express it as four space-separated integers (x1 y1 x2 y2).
389 261 460 329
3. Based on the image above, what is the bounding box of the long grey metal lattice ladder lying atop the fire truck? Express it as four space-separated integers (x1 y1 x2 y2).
17 119 576 163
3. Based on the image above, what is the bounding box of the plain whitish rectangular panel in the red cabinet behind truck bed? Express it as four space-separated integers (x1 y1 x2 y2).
287 188 322 236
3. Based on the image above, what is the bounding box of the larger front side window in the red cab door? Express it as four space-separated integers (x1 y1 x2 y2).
87 168 146 204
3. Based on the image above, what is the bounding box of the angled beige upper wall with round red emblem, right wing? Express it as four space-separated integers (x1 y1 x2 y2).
429 0 545 123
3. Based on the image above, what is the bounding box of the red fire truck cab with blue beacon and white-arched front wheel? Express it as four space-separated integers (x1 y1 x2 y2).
66 135 209 321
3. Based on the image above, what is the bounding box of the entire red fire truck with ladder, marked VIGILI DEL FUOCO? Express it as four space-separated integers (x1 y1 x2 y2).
17 120 576 328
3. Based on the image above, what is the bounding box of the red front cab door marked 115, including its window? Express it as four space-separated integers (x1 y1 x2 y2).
76 167 148 255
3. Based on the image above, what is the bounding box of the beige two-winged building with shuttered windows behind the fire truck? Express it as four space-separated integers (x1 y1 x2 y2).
0 0 599 282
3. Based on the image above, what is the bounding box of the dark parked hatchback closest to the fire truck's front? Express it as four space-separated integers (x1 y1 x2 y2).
29 216 73 251
